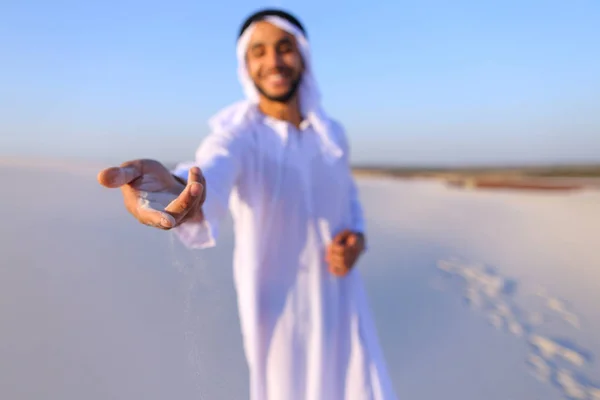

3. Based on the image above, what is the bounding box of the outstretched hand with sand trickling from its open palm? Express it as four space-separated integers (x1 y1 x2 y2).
98 160 206 230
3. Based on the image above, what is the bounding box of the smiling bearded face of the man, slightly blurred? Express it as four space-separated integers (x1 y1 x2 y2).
246 21 304 102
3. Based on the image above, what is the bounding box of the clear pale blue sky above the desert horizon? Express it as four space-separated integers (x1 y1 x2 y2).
0 0 600 165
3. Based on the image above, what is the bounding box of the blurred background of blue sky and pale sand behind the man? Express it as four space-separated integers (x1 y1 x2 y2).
0 0 600 400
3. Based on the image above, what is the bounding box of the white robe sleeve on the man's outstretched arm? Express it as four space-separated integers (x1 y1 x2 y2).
172 133 243 249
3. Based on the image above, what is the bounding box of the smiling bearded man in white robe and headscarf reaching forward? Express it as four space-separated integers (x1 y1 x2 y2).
98 10 396 400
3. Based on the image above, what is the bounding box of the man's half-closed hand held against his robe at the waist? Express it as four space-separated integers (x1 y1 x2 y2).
326 230 365 276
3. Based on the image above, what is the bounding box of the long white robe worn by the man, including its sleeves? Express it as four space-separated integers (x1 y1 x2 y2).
174 106 396 400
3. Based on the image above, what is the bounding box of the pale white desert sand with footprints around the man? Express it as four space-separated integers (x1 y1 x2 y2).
0 160 600 400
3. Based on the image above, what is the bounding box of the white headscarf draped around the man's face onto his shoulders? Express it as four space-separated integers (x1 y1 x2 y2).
209 16 342 161
